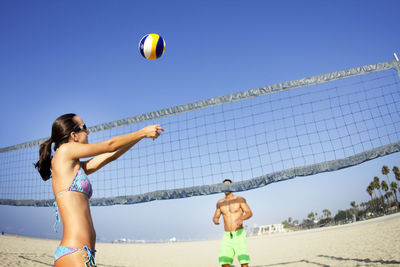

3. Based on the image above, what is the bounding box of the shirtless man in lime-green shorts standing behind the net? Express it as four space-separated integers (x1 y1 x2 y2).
213 179 253 267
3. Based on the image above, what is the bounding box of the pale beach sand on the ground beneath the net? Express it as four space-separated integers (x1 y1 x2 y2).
0 213 400 267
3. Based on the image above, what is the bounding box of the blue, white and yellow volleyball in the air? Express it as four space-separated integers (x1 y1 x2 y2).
139 33 165 60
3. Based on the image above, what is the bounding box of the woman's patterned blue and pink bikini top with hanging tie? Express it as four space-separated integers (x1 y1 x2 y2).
53 167 93 232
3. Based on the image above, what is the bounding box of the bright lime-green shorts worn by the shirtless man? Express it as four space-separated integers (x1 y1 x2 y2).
219 229 250 265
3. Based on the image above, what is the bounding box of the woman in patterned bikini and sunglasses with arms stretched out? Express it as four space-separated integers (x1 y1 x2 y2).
35 114 164 267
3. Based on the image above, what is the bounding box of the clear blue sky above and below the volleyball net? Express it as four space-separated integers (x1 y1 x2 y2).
0 0 400 242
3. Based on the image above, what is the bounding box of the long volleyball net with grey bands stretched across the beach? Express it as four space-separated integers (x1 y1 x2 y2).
0 60 400 206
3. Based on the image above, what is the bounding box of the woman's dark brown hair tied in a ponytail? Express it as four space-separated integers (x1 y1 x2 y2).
35 113 79 181
